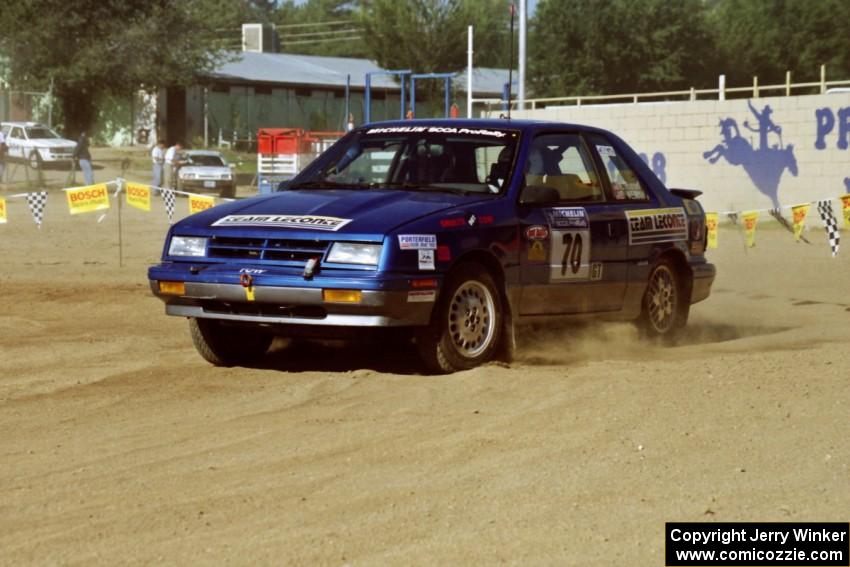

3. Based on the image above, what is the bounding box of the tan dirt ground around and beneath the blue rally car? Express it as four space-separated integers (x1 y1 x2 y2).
0 194 850 565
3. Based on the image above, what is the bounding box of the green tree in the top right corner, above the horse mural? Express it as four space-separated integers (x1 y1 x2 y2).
711 0 850 84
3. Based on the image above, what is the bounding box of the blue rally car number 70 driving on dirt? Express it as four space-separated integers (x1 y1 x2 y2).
149 120 715 372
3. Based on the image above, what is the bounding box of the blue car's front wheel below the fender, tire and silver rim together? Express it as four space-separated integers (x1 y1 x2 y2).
416 263 504 374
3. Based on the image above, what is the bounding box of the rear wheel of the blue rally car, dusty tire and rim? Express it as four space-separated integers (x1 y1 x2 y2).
638 258 691 344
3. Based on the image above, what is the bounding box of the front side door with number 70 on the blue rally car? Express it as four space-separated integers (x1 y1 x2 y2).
519 132 626 315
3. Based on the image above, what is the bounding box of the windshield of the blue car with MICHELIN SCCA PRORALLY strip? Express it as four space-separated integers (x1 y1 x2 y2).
291 126 519 194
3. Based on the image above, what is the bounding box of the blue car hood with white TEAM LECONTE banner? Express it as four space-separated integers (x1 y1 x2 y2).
179 189 493 240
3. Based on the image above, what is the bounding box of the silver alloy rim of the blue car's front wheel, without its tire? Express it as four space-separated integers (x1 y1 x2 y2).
448 280 496 358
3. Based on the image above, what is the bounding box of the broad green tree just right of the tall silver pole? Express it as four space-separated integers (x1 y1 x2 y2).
529 0 714 96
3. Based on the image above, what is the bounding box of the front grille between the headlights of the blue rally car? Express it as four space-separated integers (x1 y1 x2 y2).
207 236 330 267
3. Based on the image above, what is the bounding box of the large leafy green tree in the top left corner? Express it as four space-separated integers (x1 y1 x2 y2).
0 0 237 136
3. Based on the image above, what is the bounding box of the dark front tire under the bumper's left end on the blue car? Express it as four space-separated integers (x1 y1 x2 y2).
189 318 273 366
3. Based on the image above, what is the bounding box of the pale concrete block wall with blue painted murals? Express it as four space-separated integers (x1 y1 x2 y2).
513 93 850 211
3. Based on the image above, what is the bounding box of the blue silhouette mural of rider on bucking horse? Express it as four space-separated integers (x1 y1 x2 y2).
702 100 797 208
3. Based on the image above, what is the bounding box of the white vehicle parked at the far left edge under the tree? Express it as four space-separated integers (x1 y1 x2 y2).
0 122 77 169
